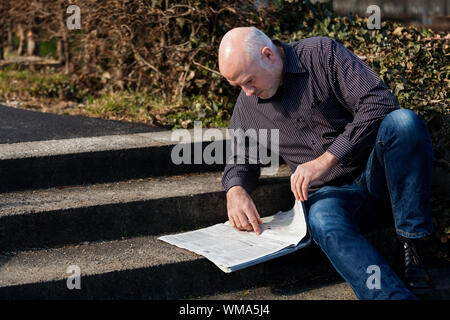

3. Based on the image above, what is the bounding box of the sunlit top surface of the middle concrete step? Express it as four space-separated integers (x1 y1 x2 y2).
0 165 290 217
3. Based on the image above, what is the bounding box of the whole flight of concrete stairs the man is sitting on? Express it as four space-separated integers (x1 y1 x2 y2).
0 131 448 299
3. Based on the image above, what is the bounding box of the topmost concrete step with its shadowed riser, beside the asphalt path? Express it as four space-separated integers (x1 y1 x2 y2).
0 129 227 192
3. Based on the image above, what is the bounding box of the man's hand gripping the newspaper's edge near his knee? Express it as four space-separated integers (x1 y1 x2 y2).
291 152 338 201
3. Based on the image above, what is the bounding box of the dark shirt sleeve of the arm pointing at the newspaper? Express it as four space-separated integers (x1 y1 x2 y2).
222 93 261 193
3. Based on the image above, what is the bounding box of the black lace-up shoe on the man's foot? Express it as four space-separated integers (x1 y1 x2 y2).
398 236 431 293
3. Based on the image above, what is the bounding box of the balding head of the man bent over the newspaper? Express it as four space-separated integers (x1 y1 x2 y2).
219 27 283 98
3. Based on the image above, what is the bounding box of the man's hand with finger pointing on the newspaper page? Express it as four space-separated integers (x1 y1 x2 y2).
227 186 263 235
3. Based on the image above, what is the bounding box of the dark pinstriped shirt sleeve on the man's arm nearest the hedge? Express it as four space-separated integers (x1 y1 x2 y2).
322 39 399 165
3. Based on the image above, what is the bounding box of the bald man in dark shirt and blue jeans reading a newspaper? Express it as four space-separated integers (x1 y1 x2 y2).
219 27 433 299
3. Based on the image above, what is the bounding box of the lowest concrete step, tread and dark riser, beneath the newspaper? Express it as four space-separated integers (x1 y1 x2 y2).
0 231 342 299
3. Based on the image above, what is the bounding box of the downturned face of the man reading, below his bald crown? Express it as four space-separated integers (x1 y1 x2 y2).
222 47 282 99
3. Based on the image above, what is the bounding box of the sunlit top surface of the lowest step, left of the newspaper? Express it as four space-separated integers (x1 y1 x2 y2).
0 236 200 287
